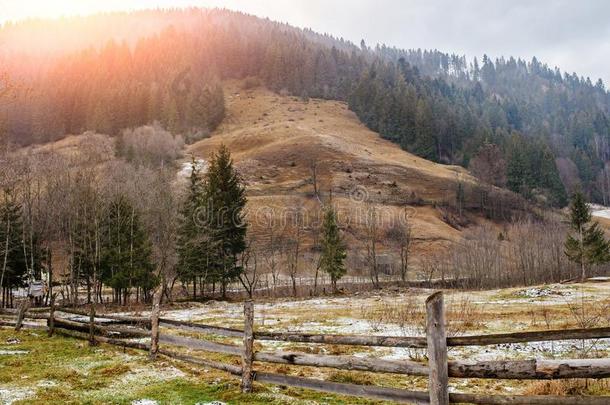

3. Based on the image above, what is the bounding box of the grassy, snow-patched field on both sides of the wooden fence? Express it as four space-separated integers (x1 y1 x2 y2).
0 283 610 405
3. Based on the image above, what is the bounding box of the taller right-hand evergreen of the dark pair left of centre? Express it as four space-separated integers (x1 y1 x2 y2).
205 145 247 297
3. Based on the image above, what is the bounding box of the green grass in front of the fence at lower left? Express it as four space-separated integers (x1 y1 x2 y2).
0 329 394 405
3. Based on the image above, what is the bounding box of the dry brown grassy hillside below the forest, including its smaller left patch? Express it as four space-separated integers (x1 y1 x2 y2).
16 81 514 280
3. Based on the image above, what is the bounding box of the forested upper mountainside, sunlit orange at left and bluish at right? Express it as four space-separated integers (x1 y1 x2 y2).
0 9 610 206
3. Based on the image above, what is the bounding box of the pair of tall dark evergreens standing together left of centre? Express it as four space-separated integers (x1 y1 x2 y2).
177 146 247 299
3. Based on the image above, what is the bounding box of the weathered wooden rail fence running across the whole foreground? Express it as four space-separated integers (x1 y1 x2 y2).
0 292 610 405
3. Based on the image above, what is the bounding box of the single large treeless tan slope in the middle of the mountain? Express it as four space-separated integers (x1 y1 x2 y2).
188 82 482 266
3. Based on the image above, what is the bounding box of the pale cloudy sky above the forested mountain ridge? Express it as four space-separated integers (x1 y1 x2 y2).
0 0 610 83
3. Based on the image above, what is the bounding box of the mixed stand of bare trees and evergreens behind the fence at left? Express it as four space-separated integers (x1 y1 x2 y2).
0 134 188 306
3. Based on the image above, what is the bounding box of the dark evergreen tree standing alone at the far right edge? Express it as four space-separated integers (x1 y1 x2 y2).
565 193 610 281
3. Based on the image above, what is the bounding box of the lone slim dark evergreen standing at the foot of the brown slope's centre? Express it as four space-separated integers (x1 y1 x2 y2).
320 205 347 292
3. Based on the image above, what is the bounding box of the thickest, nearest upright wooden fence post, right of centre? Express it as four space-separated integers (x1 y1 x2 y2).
426 291 449 405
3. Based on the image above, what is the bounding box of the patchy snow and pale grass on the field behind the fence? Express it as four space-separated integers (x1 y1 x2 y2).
116 283 610 361
